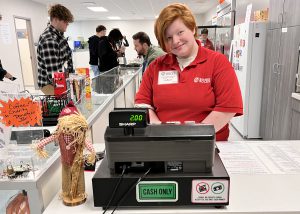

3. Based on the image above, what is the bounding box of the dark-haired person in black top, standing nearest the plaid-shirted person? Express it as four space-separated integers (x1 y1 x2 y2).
88 25 106 76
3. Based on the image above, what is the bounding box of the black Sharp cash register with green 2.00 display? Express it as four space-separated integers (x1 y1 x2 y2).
92 109 230 210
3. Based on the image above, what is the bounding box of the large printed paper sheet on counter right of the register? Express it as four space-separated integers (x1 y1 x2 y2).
218 141 300 174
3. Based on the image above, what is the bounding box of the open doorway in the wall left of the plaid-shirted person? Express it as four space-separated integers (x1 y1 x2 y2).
14 16 38 90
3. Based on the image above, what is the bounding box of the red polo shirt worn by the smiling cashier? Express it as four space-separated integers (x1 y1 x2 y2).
135 41 243 141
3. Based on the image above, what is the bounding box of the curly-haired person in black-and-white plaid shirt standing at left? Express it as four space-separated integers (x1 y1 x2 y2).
37 4 74 95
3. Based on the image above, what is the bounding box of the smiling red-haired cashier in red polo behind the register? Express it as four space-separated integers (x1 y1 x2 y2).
135 3 243 141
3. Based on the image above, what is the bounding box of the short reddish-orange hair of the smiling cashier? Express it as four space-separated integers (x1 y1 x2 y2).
154 3 197 52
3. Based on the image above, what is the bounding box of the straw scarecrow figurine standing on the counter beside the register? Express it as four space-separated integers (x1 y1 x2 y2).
36 101 95 206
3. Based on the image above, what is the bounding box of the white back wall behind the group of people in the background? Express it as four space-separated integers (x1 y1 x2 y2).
65 20 158 60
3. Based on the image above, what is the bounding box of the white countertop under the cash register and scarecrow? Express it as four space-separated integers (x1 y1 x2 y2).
44 141 300 214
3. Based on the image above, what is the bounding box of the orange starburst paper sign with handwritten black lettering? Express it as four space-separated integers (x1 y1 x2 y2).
0 97 42 127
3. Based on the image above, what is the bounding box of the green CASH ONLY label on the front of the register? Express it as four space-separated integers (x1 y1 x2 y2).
136 181 178 202
